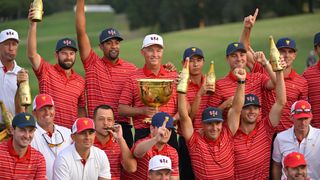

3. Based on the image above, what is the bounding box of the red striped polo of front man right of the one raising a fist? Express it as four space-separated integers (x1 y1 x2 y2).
234 119 275 180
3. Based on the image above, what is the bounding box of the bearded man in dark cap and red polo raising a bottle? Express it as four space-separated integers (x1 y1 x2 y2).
27 8 86 128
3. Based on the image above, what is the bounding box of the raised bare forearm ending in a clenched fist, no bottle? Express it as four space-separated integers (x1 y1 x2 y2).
228 68 246 135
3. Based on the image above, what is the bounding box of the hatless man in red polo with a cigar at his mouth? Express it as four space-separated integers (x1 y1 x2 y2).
93 105 137 180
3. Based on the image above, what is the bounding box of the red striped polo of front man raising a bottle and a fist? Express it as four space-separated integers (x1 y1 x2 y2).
187 126 234 180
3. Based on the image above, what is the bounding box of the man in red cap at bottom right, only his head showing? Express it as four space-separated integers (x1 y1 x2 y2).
283 152 310 180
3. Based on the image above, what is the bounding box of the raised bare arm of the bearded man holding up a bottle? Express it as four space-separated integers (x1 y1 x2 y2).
27 8 41 70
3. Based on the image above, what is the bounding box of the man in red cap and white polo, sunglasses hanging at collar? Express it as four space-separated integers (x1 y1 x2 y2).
31 94 72 180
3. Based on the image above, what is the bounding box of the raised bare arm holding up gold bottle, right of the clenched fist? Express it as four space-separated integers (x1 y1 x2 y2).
269 58 287 127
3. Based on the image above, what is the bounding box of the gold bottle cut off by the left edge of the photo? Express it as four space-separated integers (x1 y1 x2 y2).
0 101 13 142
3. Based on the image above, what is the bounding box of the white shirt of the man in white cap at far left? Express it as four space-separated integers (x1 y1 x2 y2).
0 61 21 123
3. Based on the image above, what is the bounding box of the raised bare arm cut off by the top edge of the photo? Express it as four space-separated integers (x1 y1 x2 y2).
76 0 91 62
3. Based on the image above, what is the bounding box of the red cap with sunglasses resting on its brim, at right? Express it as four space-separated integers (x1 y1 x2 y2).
291 100 312 119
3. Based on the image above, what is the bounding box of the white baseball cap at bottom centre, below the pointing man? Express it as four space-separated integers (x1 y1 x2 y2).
149 155 173 171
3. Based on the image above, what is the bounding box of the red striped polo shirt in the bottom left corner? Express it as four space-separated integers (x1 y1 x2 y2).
0 138 47 180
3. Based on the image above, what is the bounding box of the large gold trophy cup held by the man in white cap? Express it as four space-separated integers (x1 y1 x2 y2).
137 79 173 123
